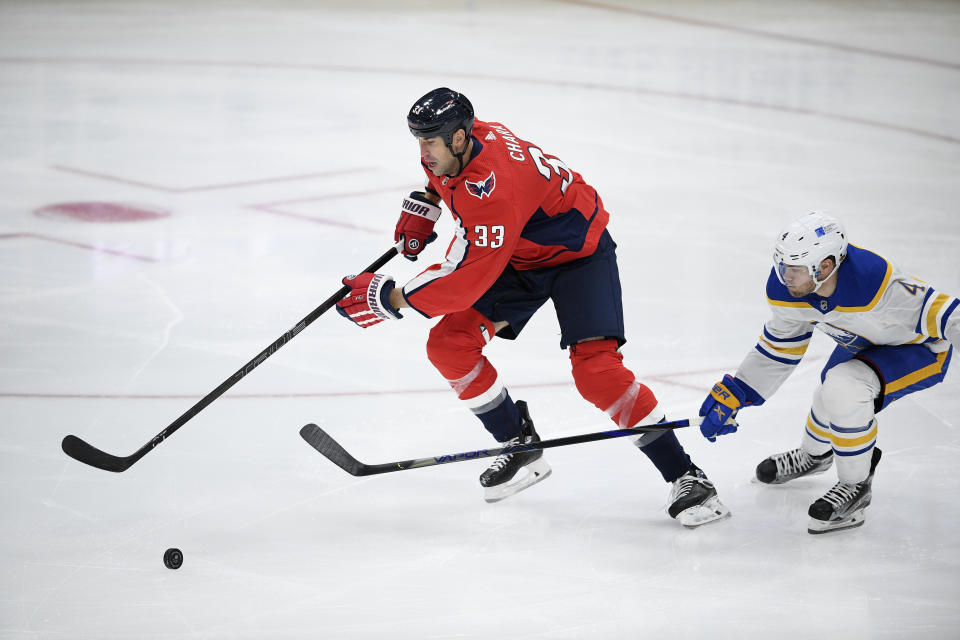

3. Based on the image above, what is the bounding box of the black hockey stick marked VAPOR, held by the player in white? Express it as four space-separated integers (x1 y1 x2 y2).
300 418 703 476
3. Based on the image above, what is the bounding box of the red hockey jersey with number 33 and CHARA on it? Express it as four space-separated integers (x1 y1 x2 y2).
403 120 610 317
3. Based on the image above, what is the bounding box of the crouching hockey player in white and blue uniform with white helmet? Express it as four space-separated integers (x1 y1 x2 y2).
700 212 960 533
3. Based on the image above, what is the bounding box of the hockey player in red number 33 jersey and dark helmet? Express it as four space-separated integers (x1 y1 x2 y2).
337 88 729 527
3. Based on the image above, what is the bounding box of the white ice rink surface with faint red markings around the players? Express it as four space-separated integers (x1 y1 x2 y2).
0 0 960 640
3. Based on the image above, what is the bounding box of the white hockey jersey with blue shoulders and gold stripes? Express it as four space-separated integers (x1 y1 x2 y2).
736 245 960 399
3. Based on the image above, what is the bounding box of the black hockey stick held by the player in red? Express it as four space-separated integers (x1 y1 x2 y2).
60 244 401 473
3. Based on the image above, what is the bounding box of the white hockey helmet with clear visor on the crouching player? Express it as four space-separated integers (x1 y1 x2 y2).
773 211 847 291
